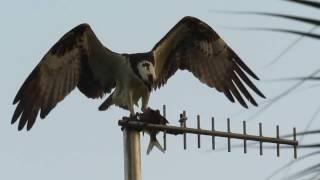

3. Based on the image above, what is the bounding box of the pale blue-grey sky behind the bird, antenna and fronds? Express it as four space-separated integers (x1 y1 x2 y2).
0 0 320 180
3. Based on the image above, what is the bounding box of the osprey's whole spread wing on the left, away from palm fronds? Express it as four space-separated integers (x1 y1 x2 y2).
11 24 123 130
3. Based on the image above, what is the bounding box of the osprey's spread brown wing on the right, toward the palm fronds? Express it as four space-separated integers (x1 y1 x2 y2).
152 16 265 107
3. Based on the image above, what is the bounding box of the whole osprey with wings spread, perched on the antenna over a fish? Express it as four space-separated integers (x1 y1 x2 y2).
11 16 265 130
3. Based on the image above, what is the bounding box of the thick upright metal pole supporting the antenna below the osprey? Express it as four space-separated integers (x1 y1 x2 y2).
123 128 141 180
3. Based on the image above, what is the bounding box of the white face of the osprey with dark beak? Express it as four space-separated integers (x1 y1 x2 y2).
137 60 156 85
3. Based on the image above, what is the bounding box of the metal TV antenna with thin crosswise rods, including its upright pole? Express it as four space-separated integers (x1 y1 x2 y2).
118 105 298 180
